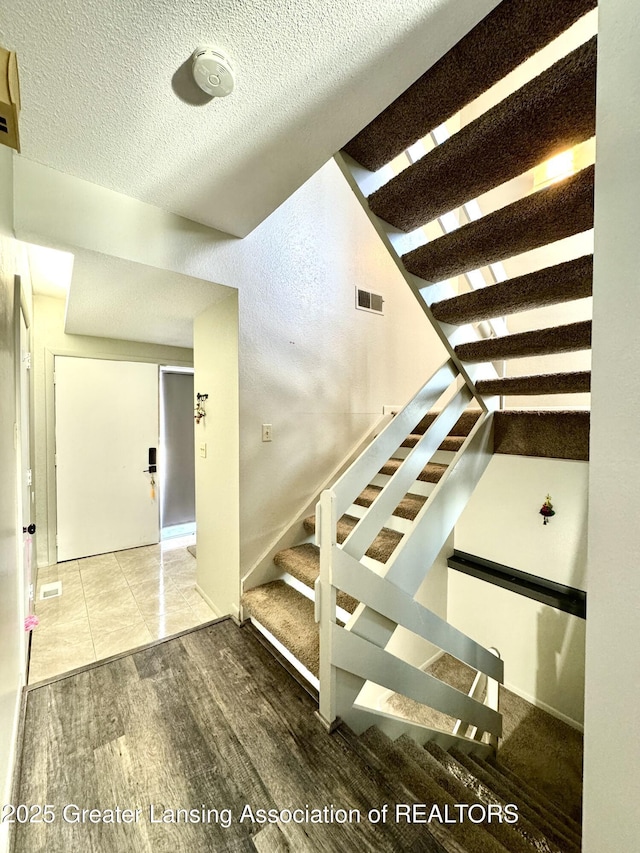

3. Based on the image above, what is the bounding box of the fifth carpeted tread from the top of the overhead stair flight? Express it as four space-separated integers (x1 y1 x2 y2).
455 320 591 362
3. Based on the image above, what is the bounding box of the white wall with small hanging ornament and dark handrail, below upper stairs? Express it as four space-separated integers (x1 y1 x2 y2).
448 454 589 726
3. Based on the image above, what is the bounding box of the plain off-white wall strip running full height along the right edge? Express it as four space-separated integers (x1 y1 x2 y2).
583 0 640 853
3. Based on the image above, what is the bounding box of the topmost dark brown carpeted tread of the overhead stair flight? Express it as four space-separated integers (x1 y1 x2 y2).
344 0 597 171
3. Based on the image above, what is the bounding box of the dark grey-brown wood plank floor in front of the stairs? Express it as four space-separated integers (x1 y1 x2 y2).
13 620 443 853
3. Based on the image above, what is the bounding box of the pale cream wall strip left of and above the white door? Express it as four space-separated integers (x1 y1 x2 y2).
32 296 193 566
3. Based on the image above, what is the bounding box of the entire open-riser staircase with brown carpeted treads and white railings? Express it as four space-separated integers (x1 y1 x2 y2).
242 0 597 851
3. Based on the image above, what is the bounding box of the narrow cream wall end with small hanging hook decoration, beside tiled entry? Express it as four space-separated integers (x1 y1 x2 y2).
194 293 240 616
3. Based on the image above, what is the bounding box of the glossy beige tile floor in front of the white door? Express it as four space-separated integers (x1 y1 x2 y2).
29 537 215 684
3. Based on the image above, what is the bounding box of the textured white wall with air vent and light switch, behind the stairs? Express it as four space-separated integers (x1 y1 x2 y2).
16 159 445 612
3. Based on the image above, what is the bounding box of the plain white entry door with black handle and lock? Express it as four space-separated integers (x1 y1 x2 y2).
55 356 159 562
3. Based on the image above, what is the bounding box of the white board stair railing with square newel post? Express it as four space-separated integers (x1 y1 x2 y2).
316 360 503 751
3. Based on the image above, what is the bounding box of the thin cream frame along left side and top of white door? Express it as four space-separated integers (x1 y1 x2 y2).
37 347 191 566
